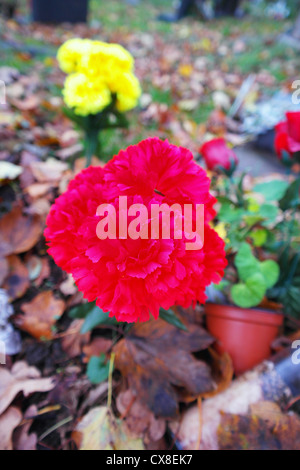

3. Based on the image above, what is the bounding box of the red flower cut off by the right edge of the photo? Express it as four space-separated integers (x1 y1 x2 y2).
275 112 300 158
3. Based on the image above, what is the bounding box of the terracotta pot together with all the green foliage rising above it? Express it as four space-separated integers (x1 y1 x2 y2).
205 153 300 374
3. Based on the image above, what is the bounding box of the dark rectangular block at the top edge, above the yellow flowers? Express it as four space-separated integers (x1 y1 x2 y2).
32 0 89 23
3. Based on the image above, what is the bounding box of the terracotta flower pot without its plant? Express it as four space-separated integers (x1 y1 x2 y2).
205 303 284 375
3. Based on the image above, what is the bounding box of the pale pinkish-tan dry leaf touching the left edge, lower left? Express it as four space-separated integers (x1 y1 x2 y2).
0 361 54 415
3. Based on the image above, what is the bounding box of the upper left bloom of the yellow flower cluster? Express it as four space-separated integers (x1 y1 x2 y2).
57 38 93 73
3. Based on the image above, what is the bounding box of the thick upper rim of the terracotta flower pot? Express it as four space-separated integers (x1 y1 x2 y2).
205 302 284 326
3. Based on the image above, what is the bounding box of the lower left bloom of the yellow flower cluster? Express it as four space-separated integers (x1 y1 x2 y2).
63 73 111 116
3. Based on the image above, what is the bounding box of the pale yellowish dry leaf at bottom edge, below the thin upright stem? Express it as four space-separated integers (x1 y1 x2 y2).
72 406 144 450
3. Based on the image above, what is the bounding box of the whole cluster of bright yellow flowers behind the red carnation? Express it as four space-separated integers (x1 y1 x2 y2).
57 39 141 116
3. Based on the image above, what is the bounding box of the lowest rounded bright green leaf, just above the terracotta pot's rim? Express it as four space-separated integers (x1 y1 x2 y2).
231 273 266 308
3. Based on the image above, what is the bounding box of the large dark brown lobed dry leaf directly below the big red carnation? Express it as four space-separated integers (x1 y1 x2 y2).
114 319 214 417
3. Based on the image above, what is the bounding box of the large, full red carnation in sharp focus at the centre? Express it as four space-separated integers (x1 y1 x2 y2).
45 138 226 322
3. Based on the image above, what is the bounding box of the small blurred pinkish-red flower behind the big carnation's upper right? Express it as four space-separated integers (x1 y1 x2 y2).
200 138 238 174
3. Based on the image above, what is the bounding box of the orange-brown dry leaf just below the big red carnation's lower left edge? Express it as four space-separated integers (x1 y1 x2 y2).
16 291 66 339
